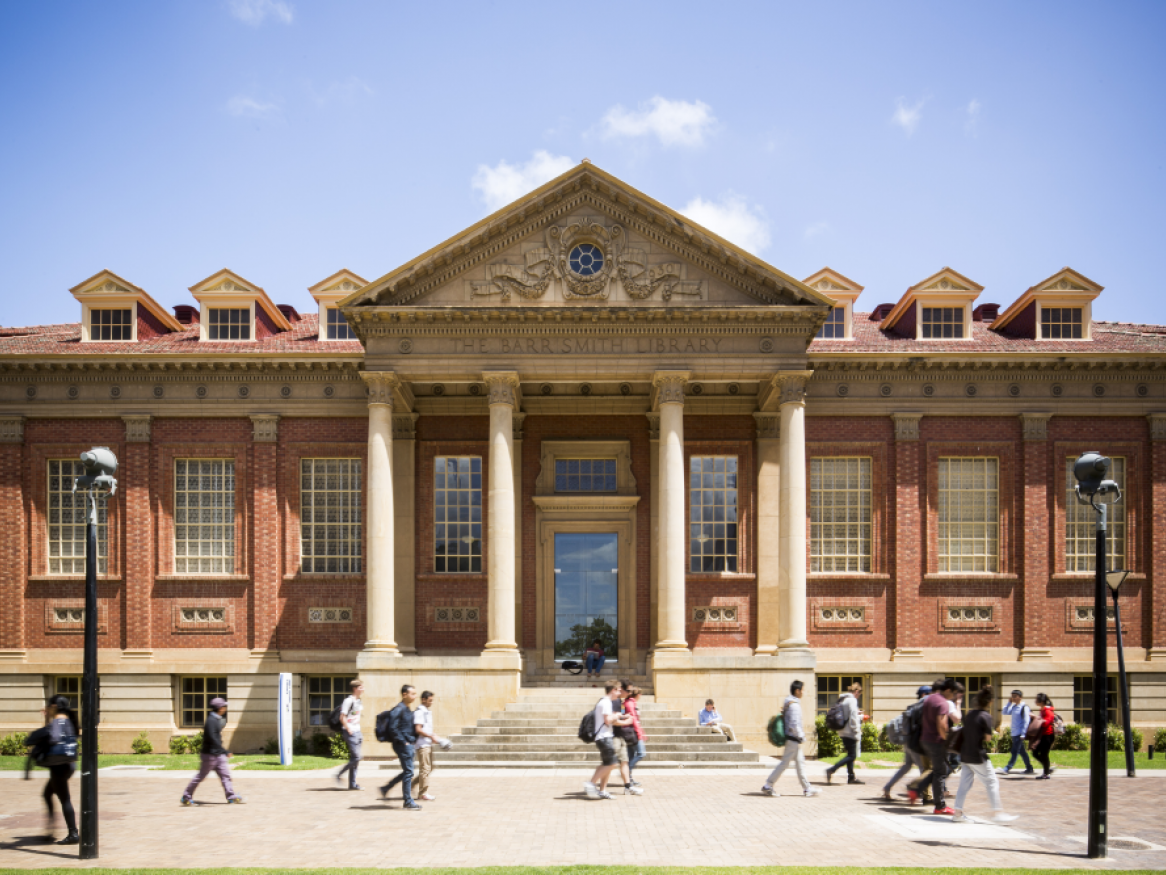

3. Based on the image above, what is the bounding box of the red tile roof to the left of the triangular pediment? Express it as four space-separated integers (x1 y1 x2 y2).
0 313 364 356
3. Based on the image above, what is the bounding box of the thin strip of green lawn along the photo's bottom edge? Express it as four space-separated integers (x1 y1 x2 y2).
4 866 1156 875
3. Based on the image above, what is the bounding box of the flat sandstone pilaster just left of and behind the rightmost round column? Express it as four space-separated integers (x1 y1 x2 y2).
753 413 785 655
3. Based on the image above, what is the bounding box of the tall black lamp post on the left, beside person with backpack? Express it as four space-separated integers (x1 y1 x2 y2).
73 447 118 860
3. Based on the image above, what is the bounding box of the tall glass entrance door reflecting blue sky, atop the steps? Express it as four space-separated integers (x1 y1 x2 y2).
555 532 619 663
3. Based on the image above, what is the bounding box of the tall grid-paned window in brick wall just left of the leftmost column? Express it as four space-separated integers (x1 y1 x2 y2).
300 459 364 574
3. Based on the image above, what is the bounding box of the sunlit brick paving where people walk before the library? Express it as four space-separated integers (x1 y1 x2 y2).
0 763 1166 869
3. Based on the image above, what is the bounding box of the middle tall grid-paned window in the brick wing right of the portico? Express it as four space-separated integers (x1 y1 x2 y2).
937 456 1000 573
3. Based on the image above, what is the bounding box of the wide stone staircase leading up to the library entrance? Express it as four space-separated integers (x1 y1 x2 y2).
434 690 759 769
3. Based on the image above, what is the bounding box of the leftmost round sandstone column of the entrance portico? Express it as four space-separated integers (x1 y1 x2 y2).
360 371 400 656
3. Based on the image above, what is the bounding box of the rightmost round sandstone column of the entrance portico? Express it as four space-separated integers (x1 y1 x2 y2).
778 371 810 650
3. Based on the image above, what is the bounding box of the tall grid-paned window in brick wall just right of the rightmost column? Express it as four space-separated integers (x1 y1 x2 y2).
809 456 871 573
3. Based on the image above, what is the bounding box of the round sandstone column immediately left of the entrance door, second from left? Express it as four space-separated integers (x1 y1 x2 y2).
483 371 519 653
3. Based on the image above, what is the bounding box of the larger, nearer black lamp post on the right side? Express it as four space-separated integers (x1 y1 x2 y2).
1073 450 1122 859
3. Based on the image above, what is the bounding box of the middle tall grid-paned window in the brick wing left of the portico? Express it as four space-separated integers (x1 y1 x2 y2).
174 459 234 574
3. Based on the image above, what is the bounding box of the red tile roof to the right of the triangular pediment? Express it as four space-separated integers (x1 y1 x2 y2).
809 313 1166 356
